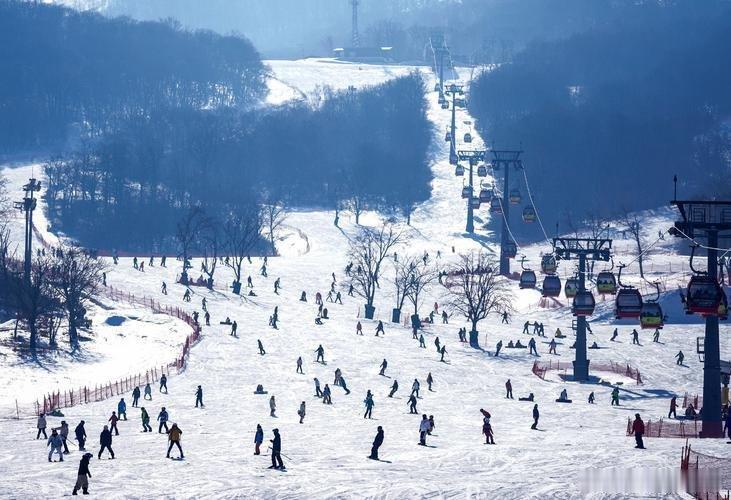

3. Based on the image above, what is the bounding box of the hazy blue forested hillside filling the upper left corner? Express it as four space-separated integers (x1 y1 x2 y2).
0 0 266 153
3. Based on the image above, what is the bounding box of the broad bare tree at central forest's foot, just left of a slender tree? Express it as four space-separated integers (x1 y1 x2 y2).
223 207 262 294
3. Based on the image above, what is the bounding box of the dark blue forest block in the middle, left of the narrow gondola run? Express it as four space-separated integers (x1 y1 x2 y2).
46 73 432 251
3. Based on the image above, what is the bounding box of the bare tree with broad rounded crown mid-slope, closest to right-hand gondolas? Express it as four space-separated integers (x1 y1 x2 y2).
445 251 513 347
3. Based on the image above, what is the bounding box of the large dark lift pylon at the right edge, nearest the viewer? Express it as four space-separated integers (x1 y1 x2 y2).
670 199 731 438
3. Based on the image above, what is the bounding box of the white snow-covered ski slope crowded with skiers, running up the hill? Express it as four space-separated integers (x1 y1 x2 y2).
0 57 731 499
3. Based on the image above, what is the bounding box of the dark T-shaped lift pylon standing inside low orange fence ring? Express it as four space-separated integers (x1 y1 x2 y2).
553 238 612 382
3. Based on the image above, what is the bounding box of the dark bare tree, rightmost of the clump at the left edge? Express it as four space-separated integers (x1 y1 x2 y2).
50 247 105 351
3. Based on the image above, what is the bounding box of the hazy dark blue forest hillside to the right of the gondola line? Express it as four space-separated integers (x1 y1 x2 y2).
469 1 731 227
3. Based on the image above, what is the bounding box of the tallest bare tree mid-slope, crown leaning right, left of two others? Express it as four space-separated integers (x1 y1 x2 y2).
348 224 403 319
